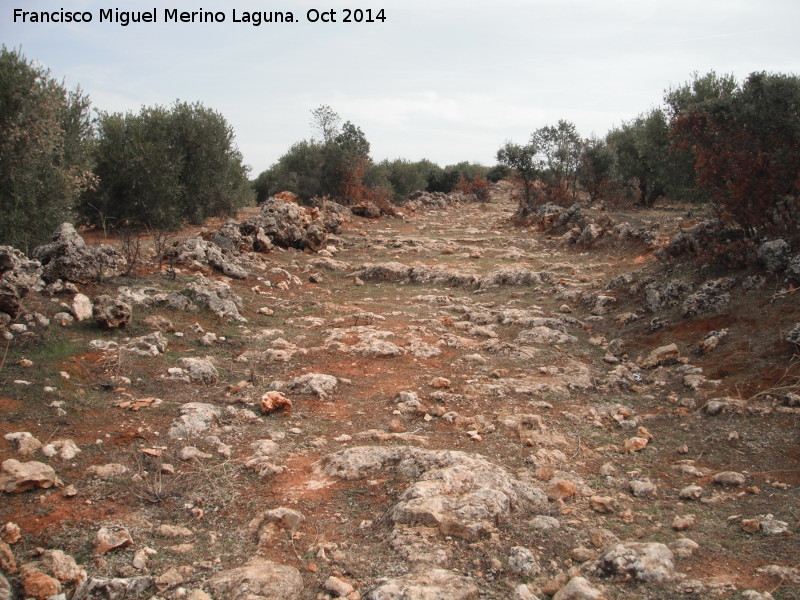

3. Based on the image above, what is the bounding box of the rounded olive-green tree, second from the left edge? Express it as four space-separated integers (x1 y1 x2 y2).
77 102 251 229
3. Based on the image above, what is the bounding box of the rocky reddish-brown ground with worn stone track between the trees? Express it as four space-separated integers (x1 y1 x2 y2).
0 188 800 600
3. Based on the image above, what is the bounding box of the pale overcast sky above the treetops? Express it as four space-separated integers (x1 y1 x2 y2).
0 0 800 176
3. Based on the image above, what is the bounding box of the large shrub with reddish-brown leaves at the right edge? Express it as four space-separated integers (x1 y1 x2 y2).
667 72 800 236
